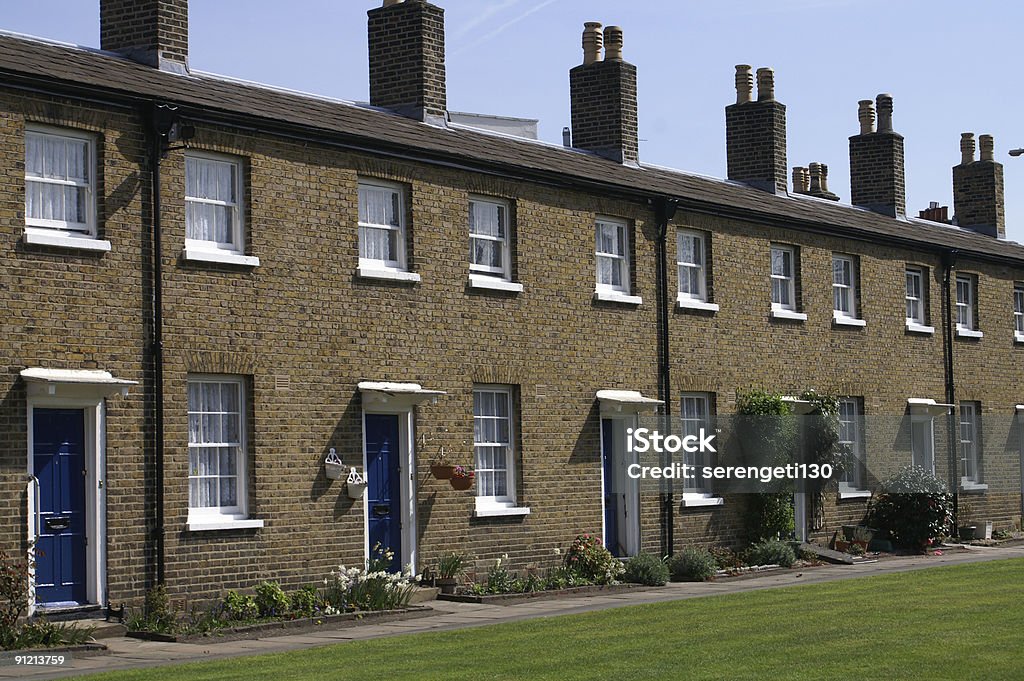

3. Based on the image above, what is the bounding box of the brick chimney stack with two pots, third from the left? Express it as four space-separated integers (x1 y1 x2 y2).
569 22 640 165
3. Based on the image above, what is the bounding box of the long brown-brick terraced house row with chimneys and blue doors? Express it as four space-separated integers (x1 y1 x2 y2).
0 0 1024 607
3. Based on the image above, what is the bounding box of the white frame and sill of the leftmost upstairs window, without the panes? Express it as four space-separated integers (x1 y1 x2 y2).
24 124 111 251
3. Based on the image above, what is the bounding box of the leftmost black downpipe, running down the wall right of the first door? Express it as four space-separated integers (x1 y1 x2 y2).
150 104 172 584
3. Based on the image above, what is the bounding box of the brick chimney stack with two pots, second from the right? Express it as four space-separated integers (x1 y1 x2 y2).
850 94 906 217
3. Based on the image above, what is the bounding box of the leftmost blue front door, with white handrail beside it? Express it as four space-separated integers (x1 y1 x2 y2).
32 409 86 604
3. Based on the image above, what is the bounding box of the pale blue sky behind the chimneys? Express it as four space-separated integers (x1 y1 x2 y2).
0 0 1024 242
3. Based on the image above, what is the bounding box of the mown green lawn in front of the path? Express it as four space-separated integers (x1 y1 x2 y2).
90 559 1024 681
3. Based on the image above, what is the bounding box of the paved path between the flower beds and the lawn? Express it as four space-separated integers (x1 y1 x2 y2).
8 546 1024 681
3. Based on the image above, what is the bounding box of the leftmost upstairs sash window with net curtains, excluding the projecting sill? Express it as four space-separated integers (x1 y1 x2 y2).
25 127 96 237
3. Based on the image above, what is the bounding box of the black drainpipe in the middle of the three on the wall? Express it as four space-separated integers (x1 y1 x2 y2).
654 198 679 556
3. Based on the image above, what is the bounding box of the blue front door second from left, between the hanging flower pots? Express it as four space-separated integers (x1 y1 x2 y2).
366 414 402 572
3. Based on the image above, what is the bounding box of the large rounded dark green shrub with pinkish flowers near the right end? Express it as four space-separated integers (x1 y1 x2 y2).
867 466 952 550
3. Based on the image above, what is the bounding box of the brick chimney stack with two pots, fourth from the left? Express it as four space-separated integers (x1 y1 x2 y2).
725 65 786 194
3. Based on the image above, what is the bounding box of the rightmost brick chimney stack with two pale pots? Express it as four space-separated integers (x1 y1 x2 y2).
953 132 1007 239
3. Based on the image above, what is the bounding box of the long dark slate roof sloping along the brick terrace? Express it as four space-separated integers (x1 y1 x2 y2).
0 34 1024 264
